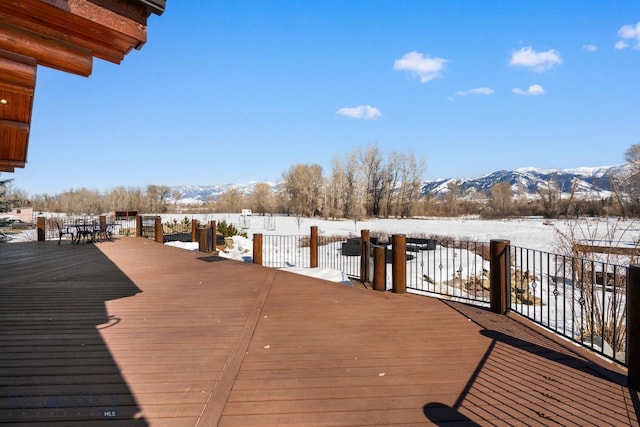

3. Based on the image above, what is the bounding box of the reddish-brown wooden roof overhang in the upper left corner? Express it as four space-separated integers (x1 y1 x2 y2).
0 0 165 172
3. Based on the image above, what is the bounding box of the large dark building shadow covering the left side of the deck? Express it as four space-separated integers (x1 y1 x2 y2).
0 243 147 426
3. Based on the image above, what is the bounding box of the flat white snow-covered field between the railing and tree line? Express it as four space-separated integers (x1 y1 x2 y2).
162 214 640 258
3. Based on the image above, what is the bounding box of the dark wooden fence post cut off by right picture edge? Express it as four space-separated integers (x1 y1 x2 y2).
627 264 640 390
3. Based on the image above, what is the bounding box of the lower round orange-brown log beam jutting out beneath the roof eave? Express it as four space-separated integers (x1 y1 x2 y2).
0 22 93 77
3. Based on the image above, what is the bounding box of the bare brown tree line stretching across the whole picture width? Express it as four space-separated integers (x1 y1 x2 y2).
0 144 640 220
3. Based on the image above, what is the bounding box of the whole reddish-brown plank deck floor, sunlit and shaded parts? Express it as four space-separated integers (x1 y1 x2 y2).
0 238 640 427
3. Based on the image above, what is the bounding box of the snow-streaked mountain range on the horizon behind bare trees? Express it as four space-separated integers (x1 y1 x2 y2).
171 164 628 203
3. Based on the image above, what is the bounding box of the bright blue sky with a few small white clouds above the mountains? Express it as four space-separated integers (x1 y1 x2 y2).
8 0 640 195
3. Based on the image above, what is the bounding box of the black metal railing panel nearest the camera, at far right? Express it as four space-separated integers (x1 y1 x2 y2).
510 246 628 365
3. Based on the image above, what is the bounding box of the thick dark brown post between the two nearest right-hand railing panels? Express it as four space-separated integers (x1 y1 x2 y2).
489 240 511 314
